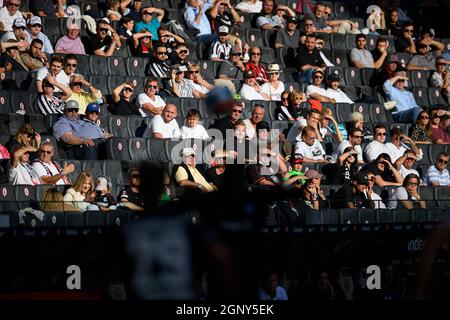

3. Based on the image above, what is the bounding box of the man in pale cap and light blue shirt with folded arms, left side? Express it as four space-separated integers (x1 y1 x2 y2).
53 100 105 160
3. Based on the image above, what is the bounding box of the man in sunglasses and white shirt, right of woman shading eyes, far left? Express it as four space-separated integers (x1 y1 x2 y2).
32 141 75 185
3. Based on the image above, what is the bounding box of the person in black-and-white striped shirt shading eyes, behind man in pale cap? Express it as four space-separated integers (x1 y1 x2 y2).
34 75 72 116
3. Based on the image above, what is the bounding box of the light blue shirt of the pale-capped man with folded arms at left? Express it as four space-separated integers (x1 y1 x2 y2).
53 115 103 140
